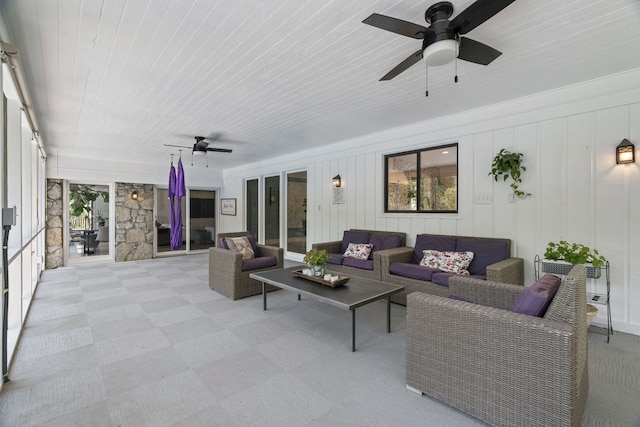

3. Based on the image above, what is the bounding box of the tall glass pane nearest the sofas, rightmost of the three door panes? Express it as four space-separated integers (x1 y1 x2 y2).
287 172 307 254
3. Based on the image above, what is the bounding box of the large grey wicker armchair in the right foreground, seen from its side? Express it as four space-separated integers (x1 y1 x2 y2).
406 266 589 426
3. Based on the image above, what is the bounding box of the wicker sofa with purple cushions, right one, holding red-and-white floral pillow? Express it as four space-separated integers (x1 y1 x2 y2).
380 234 524 305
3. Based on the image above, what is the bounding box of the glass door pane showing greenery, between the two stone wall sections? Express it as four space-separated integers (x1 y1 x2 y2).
69 184 109 258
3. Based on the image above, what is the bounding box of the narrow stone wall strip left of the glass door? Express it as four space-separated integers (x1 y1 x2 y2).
44 179 64 269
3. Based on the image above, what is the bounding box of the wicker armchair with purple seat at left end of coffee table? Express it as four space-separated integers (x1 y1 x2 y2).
209 231 284 300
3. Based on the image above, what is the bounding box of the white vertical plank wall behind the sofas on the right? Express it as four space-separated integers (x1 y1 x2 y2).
220 72 640 335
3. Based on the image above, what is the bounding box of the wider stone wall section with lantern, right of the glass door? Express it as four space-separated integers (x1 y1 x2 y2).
115 182 154 262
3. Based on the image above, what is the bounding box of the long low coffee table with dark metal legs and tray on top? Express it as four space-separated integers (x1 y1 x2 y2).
249 265 404 351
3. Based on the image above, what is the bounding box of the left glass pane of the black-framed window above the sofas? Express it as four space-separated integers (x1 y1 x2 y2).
387 153 418 211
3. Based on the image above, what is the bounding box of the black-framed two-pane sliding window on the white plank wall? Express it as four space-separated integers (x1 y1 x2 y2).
384 143 458 213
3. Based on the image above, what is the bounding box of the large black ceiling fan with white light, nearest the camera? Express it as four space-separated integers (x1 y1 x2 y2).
362 0 515 92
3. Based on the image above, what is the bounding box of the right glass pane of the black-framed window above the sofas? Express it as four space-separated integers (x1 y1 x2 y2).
420 147 458 212
